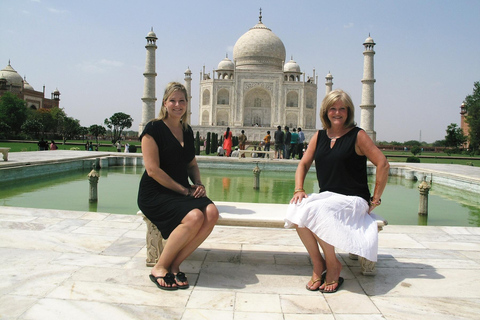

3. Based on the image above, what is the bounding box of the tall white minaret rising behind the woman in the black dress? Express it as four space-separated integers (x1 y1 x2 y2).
138 28 158 135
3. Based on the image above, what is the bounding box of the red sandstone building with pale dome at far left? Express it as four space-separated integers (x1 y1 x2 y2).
0 61 60 110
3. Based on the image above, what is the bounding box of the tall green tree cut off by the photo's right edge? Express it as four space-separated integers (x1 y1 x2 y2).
465 81 480 153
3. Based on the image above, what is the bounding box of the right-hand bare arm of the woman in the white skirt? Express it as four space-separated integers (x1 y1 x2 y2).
355 130 390 212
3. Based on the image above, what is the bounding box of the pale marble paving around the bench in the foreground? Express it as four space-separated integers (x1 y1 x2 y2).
0 153 480 320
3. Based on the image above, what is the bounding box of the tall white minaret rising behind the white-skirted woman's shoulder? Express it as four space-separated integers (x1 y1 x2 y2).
360 35 377 142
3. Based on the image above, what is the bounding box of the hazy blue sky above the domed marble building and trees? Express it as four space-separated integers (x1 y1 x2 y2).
0 0 480 142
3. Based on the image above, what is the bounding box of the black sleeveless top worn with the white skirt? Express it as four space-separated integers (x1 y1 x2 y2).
315 127 370 202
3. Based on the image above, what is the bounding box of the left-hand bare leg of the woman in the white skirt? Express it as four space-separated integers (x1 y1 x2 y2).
296 226 325 290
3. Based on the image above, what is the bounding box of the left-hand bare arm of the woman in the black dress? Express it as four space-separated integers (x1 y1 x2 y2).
142 134 190 195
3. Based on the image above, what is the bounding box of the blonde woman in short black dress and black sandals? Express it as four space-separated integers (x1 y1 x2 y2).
138 82 218 290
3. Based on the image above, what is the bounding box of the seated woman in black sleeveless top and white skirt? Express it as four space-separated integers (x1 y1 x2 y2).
285 90 389 293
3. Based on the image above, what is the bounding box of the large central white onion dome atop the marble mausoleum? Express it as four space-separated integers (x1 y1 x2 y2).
233 20 285 71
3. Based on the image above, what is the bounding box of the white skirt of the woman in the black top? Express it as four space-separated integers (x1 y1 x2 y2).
285 191 378 261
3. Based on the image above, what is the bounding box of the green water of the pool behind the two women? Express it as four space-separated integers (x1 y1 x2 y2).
0 167 480 227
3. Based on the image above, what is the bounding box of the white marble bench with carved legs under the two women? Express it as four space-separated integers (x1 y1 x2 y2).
137 202 388 275
